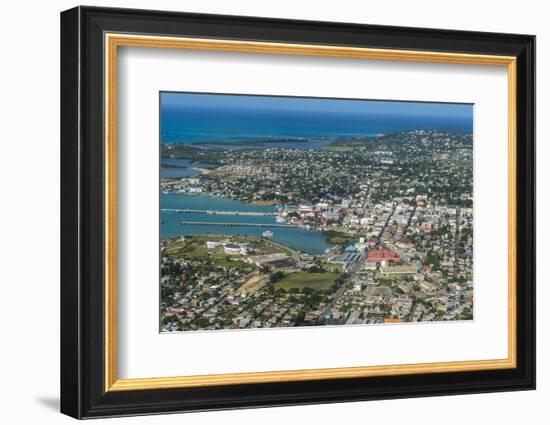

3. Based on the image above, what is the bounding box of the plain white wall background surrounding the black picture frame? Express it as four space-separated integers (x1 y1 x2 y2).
0 0 550 425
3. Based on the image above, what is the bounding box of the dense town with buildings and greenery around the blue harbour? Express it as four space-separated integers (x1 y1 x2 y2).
160 130 474 332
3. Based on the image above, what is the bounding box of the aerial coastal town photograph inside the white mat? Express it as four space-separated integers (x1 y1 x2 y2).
159 91 475 332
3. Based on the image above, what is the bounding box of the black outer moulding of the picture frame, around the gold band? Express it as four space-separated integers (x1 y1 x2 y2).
61 7 535 418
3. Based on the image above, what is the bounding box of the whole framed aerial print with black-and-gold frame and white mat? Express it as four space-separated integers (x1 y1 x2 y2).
61 7 535 418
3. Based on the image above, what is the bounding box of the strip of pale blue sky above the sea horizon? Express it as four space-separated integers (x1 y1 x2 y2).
161 92 473 117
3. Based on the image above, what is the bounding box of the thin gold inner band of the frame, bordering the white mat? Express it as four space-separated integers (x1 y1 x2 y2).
105 33 517 391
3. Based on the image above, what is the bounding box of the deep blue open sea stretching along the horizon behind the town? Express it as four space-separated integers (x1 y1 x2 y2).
161 105 473 143
